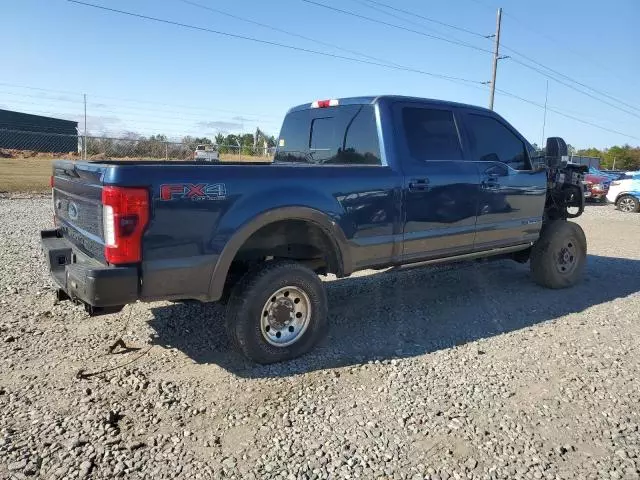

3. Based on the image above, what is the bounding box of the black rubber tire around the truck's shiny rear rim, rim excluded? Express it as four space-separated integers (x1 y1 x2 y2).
226 260 328 364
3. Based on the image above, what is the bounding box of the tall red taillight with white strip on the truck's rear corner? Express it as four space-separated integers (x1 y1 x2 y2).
102 187 149 264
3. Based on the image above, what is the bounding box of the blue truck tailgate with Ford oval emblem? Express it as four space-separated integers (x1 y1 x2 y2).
52 161 105 263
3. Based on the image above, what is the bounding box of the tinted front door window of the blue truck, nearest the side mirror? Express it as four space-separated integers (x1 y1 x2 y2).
467 114 531 170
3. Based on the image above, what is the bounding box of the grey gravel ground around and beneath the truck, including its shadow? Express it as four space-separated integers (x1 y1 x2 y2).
0 198 640 480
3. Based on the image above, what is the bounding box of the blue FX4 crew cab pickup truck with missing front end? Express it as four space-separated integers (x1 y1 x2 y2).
41 96 587 363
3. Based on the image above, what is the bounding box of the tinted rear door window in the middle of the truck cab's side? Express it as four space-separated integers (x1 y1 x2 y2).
402 107 462 161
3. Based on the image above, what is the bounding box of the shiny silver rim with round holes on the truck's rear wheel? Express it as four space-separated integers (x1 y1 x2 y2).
260 286 311 347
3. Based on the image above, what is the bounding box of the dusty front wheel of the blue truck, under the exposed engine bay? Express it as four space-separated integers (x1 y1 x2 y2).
530 220 587 288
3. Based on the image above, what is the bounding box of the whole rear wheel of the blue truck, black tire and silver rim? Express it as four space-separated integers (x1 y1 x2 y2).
227 261 327 364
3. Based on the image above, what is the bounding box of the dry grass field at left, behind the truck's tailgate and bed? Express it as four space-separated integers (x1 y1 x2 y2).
0 154 271 193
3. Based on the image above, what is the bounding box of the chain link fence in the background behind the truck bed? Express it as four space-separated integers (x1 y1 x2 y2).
0 129 274 162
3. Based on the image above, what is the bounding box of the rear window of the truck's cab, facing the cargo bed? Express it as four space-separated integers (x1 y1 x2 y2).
275 105 381 165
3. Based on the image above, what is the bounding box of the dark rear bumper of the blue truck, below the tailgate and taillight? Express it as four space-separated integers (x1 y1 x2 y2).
40 230 140 313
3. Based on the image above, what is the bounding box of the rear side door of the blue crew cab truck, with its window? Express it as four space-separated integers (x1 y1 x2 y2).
394 102 480 262
